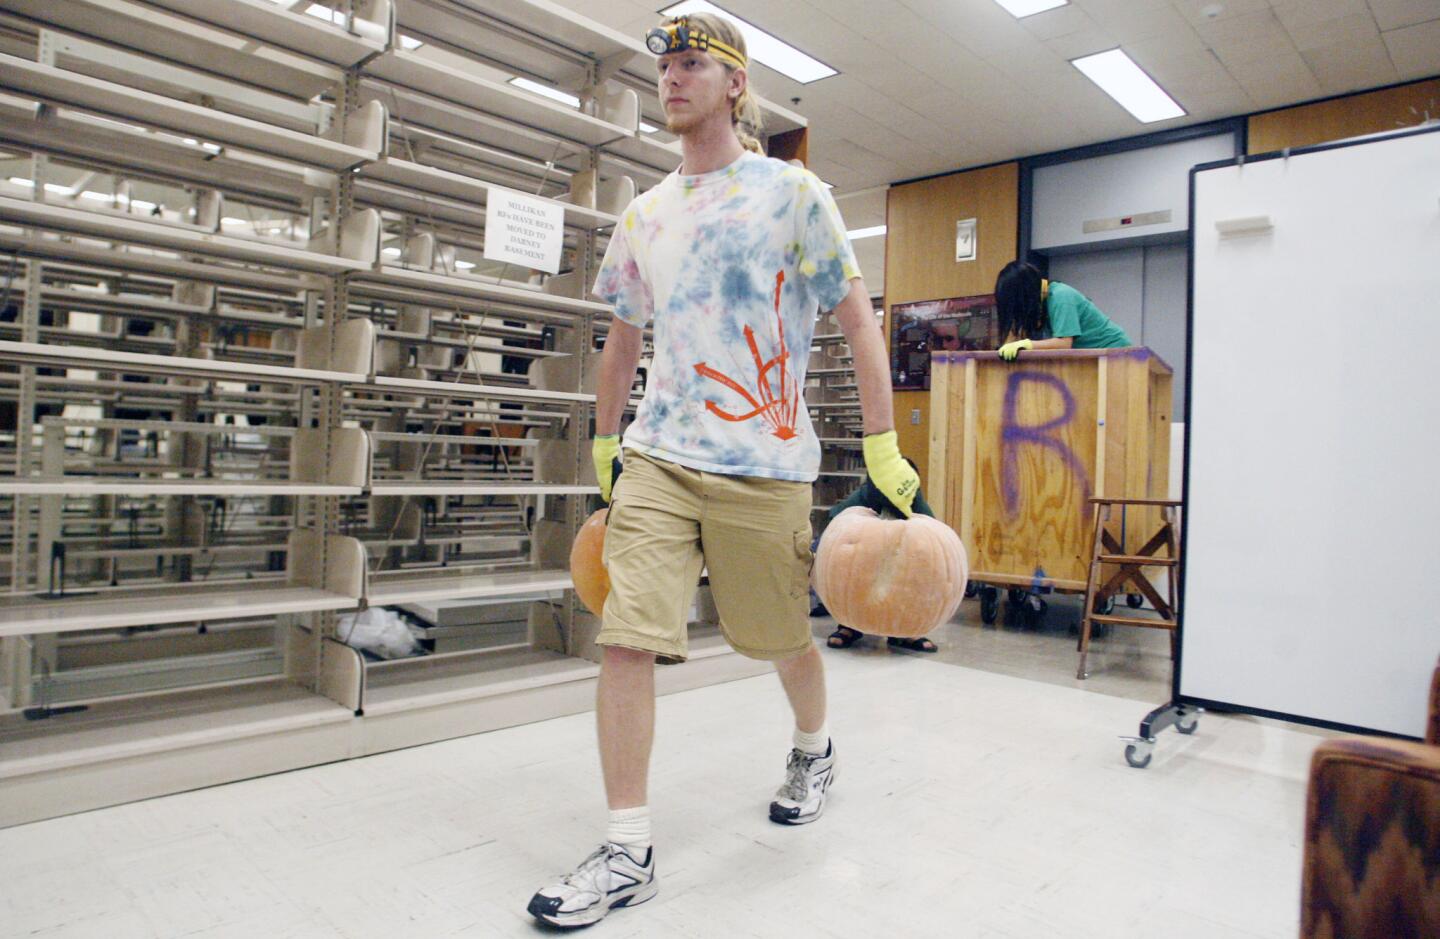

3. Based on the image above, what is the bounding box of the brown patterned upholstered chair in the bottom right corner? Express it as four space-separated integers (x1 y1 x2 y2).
1300 656 1440 939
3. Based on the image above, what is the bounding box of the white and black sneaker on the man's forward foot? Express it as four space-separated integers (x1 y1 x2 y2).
528 841 660 929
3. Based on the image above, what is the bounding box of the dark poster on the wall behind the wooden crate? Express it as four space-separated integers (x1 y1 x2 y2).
890 294 998 392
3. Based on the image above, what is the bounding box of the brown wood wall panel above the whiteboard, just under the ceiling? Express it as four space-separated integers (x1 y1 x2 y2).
1247 78 1440 154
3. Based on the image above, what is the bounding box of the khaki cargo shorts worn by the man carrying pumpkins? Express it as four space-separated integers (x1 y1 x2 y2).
595 451 812 661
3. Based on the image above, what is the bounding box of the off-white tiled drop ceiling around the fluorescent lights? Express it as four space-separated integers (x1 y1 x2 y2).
560 0 1440 262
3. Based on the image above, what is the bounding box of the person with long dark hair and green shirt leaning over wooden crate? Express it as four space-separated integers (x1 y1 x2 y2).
995 261 1135 361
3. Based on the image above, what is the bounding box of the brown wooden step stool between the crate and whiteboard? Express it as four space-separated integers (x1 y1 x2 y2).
1076 498 1181 680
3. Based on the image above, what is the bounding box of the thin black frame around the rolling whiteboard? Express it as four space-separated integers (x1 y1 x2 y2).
1175 125 1440 740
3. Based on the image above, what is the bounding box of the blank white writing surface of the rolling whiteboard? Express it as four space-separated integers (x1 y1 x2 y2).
1175 131 1440 736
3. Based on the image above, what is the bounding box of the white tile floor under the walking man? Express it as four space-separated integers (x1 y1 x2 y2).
0 634 1319 939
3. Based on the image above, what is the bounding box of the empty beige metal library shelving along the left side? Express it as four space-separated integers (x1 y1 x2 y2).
0 0 804 825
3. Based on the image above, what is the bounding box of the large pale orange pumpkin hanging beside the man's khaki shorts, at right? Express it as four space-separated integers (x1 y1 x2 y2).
814 506 969 639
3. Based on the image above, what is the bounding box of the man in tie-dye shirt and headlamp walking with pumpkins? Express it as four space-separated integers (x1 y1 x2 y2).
528 16 919 927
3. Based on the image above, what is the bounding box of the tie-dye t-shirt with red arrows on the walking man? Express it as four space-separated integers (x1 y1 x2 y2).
595 151 860 482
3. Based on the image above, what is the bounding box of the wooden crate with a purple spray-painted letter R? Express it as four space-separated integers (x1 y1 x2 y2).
929 347 1172 590
